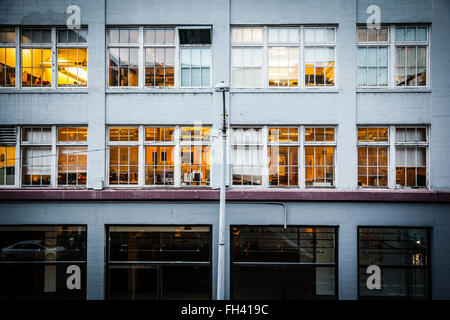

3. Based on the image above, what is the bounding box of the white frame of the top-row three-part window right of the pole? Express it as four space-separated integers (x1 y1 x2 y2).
228 25 338 90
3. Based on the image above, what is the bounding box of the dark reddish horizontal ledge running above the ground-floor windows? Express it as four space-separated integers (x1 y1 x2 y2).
0 189 450 202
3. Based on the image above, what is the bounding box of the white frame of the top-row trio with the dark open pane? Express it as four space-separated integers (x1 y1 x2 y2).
105 25 213 92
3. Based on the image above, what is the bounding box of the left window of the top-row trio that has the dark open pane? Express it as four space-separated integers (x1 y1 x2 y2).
108 29 139 87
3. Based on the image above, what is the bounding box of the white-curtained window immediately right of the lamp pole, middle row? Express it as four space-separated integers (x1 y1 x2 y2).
231 128 263 185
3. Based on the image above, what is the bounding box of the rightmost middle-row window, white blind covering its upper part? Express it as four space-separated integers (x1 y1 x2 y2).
395 127 428 188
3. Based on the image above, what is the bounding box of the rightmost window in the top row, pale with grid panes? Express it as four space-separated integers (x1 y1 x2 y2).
395 27 428 87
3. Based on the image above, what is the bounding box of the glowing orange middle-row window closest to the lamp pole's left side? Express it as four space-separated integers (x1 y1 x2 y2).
180 127 211 186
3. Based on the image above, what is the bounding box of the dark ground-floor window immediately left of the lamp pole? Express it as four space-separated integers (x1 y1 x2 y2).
106 225 211 300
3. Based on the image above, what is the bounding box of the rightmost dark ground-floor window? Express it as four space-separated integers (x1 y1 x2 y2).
358 227 431 300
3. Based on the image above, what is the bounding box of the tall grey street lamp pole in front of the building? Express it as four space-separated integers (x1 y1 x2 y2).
215 81 230 300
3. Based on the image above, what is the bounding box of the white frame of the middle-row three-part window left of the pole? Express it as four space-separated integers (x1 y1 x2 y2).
105 124 213 189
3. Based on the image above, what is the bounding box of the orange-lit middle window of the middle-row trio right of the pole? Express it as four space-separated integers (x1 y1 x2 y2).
268 128 299 186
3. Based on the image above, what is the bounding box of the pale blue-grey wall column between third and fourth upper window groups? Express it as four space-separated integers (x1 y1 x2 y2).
336 0 358 190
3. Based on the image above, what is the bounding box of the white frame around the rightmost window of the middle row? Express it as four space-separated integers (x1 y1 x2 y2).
391 125 431 190
